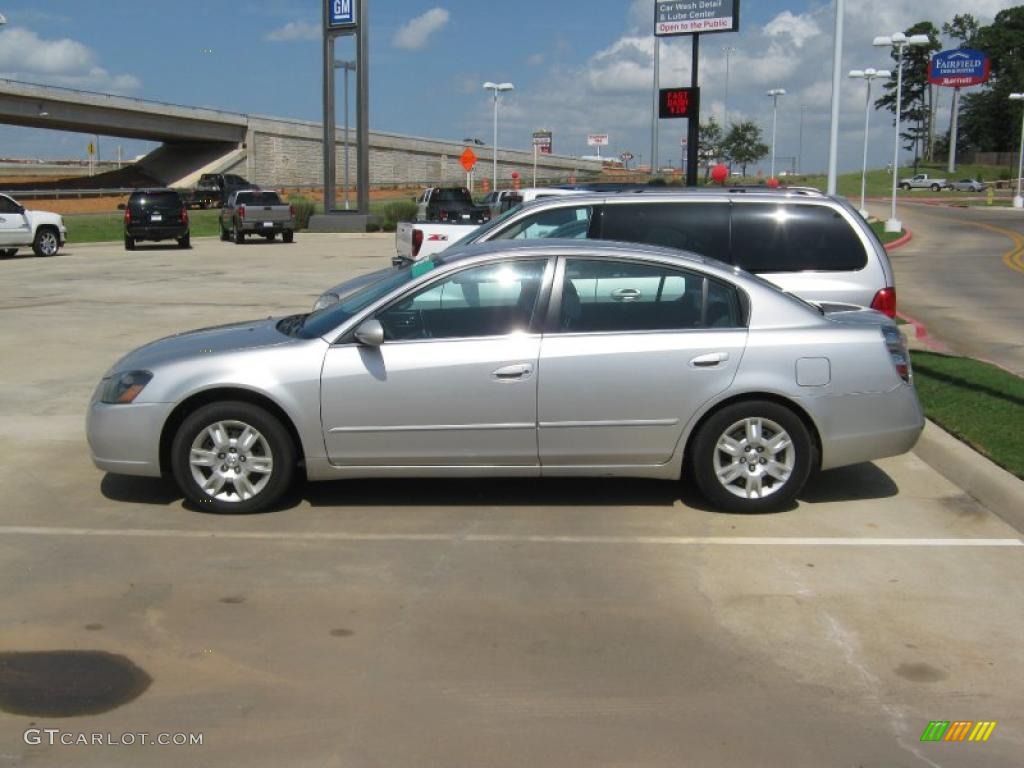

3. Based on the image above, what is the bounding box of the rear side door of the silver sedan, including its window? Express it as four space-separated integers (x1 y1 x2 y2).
538 259 746 468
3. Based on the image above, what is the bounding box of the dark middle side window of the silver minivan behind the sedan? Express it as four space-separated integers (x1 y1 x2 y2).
601 203 729 261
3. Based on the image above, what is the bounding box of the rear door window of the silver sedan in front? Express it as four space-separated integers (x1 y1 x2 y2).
559 259 742 333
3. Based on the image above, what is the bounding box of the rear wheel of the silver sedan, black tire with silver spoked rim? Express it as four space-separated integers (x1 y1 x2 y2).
690 400 817 513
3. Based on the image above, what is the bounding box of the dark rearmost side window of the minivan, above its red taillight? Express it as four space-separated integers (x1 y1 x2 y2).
732 203 867 272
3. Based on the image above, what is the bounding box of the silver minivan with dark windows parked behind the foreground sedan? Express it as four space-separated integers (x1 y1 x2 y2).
337 188 896 316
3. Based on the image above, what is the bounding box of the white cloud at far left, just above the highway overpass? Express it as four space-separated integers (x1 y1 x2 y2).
0 27 141 93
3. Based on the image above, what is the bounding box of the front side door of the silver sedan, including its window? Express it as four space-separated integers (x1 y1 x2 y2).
321 258 553 468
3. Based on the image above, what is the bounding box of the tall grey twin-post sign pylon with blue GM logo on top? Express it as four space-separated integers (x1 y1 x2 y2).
310 0 370 231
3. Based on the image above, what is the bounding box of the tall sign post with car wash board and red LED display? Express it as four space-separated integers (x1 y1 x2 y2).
651 0 739 186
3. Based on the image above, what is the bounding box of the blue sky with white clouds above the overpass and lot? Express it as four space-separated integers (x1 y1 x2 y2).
0 0 1019 172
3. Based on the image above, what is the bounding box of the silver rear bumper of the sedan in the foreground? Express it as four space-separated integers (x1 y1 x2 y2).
814 385 925 469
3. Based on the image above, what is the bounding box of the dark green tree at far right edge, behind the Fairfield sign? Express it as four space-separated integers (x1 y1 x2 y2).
961 5 1024 152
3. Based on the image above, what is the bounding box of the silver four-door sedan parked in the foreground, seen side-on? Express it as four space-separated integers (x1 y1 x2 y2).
87 241 924 512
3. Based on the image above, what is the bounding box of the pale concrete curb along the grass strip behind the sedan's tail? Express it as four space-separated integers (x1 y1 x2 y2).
913 421 1024 532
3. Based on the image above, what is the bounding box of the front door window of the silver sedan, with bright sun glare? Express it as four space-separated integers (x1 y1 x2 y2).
377 259 547 340
